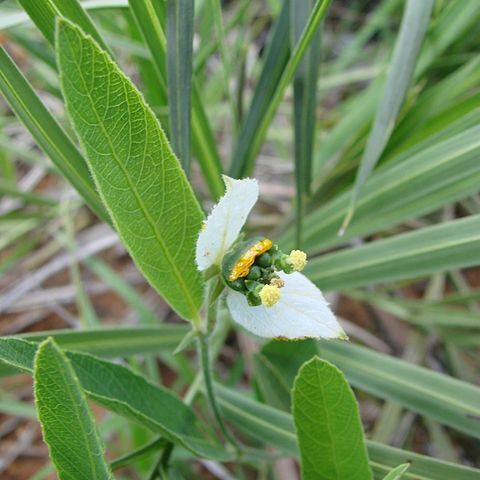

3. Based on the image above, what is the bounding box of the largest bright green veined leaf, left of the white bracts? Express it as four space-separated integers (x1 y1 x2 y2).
56 19 203 320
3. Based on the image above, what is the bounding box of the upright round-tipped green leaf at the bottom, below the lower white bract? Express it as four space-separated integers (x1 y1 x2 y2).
292 357 372 480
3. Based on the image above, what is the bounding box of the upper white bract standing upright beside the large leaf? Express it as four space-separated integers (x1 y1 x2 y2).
196 175 258 271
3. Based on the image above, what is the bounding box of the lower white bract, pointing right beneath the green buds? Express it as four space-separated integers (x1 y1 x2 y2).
227 272 346 340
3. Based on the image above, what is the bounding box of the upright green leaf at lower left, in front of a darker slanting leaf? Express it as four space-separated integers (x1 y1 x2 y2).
34 339 112 480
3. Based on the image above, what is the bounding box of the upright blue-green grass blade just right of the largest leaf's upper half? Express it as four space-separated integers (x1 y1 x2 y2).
167 0 194 173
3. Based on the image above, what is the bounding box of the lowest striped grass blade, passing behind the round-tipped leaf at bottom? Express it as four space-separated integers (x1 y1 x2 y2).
215 384 480 480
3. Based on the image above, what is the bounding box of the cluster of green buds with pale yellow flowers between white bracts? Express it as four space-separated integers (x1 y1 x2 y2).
223 239 307 307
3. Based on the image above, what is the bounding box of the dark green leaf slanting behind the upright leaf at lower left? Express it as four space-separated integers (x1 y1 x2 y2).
0 338 229 460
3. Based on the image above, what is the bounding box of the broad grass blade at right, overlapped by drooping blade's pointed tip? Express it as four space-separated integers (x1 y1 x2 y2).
279 124 480 253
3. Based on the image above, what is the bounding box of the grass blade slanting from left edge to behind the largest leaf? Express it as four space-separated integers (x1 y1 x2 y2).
0 47 109 222
